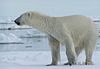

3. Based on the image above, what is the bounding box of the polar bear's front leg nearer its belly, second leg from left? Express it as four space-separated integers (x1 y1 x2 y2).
64 37 77 65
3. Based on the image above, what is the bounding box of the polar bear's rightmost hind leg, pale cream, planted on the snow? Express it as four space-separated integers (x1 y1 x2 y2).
85 37 96 65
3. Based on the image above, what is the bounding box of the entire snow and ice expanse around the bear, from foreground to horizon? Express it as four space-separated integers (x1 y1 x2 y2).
0 18 100 69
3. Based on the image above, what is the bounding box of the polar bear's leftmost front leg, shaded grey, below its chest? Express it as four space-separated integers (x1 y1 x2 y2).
47 35 60 66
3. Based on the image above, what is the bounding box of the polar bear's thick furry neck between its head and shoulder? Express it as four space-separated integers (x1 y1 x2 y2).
33 16 54 34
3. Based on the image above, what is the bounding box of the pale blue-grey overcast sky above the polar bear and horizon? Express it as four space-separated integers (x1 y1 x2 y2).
0 0 100 16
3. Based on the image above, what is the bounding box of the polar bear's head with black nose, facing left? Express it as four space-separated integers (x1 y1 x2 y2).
14 12 41 26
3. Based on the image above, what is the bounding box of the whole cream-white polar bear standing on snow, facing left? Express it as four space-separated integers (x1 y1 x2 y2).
14 12 97 66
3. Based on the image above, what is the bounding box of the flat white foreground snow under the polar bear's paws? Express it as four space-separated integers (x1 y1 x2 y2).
0 51 100 69
